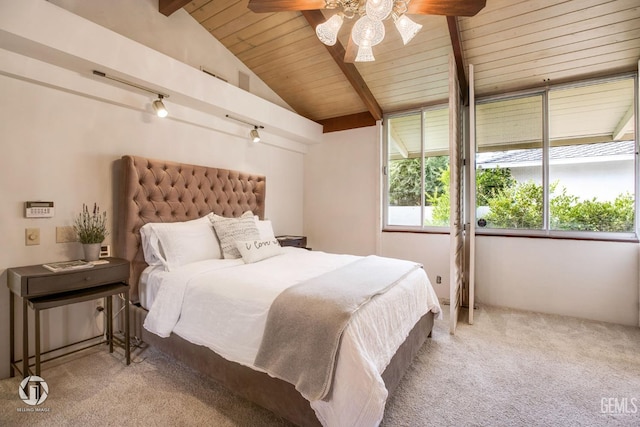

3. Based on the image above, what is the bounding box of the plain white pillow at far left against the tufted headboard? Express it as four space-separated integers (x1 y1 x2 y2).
140 216 222 271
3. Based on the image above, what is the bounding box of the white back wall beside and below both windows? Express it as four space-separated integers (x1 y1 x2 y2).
304 128 639 325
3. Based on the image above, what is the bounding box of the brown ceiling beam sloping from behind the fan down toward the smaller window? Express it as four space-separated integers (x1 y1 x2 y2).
301 10 382 120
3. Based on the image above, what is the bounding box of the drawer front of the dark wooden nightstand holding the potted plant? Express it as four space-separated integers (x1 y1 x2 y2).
27 264 129 296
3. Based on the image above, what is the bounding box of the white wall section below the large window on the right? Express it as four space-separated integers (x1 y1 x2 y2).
476 236 638 326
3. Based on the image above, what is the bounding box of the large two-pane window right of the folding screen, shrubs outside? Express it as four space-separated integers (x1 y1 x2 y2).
476 76 637 238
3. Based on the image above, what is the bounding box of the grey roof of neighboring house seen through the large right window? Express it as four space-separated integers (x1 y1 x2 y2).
476 141 635 167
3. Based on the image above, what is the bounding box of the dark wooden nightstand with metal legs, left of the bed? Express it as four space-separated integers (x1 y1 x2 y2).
7 258 131 377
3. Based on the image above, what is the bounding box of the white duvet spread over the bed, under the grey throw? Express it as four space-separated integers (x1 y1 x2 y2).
144 247 440 426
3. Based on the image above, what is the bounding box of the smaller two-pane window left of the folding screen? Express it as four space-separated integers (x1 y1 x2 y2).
385 106 449 229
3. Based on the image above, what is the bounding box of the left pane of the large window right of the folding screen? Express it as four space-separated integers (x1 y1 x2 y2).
476 94 544 230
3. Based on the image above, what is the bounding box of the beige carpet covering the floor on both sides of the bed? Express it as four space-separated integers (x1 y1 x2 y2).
0 307 640 427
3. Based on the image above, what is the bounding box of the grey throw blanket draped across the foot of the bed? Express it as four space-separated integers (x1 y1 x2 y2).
255 255 420 400
